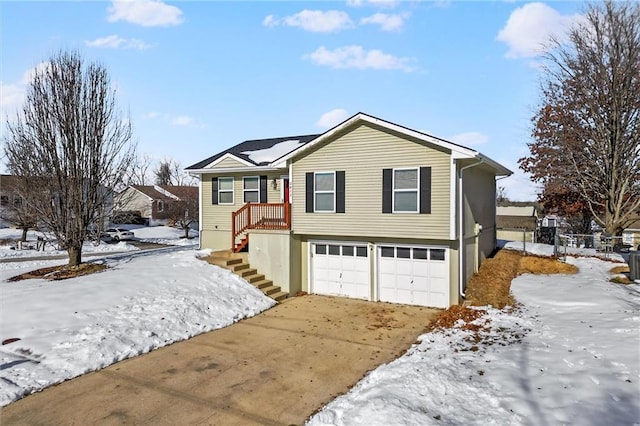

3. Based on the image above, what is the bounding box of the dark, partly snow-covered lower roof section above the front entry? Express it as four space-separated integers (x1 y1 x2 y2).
185 134 320 170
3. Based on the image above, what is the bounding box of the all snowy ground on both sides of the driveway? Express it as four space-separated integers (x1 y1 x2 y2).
0 238 640 426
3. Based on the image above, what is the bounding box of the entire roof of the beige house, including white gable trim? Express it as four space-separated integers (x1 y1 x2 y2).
185 112 513 176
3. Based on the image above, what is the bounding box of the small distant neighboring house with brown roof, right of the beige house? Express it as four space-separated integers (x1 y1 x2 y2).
496 203 538 243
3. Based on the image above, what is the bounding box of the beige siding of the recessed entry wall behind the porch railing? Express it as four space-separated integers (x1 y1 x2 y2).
201 172 282 248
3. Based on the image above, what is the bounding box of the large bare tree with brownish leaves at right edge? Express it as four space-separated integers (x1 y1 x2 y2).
521 1 640 235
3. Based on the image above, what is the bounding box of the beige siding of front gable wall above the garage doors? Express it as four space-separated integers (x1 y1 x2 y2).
292 125 451 239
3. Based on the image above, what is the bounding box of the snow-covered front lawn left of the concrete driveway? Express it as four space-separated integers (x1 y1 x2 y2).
0 250 275 405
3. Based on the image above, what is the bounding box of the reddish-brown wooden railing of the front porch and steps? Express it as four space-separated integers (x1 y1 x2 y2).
231 203 291 251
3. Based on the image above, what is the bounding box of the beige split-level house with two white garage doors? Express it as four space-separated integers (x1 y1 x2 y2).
186 113 511 308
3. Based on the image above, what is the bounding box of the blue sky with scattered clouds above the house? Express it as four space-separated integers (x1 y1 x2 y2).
0 0 584 200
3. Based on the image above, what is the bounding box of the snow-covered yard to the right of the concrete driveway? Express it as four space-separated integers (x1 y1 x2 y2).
309 258 640 425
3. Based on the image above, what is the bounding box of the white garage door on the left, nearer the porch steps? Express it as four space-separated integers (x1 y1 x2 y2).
310 243 371 300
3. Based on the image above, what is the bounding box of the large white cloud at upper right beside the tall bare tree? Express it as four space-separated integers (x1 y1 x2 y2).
496 3 581 58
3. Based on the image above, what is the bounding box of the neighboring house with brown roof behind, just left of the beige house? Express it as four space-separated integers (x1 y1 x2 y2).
114 185 199 226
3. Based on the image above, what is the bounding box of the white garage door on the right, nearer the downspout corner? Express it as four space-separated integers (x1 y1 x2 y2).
378 245 449 308
